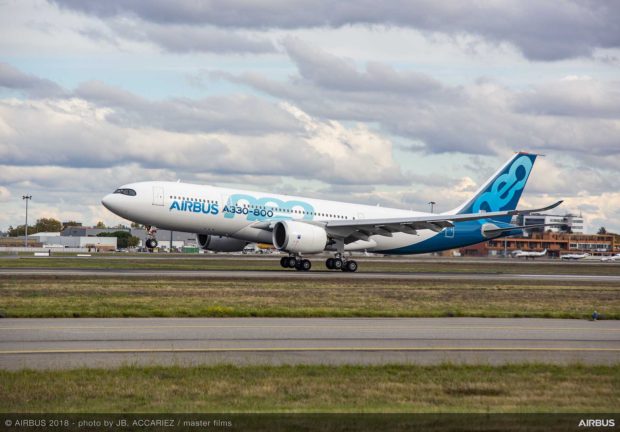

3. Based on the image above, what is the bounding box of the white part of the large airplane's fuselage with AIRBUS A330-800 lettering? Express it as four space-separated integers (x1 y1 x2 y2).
102 181 450 255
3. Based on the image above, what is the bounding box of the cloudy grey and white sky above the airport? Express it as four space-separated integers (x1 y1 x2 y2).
0 0 620 232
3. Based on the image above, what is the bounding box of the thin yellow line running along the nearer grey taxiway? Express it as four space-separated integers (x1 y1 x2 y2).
0 347 620 355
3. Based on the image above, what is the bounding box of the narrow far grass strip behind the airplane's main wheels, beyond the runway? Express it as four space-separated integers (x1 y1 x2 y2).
0 255 620 275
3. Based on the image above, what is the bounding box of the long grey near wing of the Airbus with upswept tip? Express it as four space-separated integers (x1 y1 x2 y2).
252 201 563 243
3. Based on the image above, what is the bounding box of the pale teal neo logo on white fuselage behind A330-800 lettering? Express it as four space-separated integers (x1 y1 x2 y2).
223 194 314 221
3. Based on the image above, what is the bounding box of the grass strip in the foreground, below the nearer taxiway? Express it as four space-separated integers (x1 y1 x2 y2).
0 364 620 413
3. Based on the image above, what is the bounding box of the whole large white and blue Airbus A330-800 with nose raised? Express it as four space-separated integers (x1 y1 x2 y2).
101 152 562 272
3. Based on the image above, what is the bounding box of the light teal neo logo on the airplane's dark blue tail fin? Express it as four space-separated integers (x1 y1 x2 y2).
472 156 532 213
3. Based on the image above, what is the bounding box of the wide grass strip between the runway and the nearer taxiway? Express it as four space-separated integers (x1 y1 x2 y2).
0 276 620 319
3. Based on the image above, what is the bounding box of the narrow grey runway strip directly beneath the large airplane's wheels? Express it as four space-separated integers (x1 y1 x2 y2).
0 268 620 282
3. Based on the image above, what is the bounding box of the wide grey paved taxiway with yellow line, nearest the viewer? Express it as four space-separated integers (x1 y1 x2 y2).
0 318 620 370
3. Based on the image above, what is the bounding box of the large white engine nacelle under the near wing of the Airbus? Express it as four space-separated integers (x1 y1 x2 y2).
272 221 327 253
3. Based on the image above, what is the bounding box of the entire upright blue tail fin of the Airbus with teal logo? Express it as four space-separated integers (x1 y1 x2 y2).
451 152 538 222
